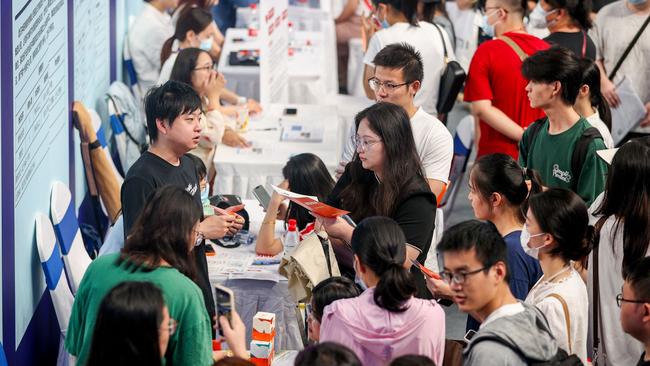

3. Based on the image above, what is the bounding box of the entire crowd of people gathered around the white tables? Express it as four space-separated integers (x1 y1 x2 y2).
65 0 650 366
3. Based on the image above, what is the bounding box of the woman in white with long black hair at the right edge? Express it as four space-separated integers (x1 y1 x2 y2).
587 137 650 365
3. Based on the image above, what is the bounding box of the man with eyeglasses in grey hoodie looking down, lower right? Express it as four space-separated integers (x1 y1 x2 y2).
438 220 560 366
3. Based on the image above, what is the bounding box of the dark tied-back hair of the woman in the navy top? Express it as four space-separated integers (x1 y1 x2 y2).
469 154 543 224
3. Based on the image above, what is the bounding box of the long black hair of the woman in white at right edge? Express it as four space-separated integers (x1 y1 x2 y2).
595 137 650 272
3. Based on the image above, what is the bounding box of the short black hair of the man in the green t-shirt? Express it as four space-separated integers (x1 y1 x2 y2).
521 46 582 105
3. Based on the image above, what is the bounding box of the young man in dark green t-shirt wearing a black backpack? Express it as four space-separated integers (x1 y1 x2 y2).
519 47 607 205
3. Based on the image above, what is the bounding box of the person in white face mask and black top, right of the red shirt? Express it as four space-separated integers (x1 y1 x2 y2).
528 0 596 60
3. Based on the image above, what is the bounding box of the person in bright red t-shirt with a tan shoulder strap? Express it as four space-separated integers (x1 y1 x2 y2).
465 0 549 159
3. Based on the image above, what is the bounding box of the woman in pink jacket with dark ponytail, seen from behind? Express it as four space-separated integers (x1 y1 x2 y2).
320 217 445 365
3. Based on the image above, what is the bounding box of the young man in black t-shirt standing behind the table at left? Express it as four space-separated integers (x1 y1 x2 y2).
122 81 244 324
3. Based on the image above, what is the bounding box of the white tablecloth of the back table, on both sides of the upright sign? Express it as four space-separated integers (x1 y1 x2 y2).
219 7 338 104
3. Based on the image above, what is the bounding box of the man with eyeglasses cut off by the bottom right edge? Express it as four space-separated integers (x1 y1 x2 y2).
616 257 650 366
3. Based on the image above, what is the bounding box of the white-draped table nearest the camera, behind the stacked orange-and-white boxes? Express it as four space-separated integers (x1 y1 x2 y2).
207 200 303 353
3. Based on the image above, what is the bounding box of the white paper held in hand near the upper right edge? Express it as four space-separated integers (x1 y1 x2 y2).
612 76 646 145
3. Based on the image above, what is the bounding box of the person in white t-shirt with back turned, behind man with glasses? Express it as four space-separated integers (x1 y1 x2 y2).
356 0 455 116
